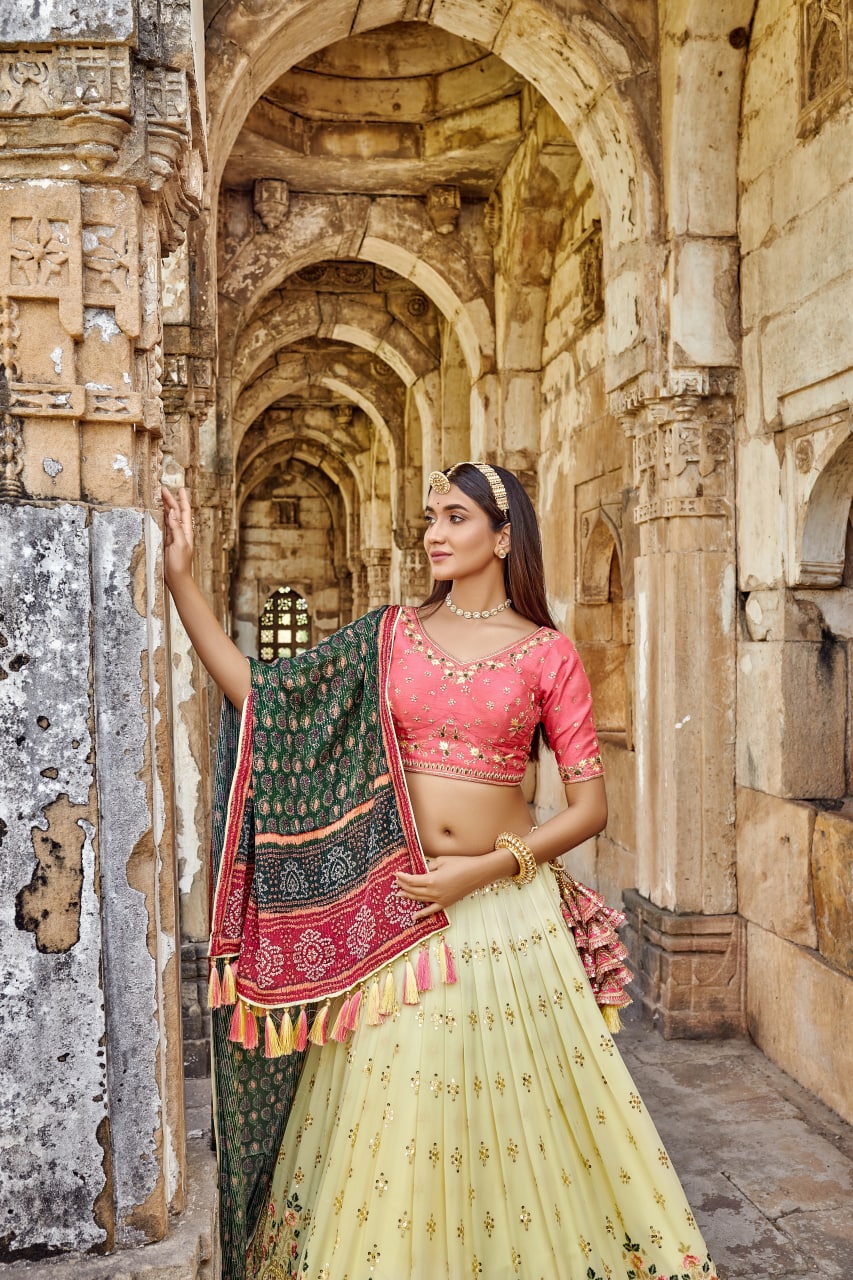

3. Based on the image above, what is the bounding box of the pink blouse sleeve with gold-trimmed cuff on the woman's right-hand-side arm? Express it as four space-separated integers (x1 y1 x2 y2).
540 632 605 782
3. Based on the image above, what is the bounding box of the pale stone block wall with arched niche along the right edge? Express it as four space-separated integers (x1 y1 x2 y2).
738 0 853 1119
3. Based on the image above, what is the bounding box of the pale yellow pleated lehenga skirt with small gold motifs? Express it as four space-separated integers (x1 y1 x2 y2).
247 869 715 1280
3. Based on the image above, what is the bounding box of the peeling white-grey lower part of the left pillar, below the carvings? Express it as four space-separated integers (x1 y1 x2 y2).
0 504 183 1258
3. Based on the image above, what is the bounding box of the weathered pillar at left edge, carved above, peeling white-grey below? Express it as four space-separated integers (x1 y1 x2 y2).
0 17 207 1270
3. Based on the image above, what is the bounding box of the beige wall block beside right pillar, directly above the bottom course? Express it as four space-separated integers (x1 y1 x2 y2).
738 787 817 947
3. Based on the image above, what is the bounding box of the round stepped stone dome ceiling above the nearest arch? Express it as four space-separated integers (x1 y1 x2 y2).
224 23 530 198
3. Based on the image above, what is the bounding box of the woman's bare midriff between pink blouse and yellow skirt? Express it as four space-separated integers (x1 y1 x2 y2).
406 771 533 858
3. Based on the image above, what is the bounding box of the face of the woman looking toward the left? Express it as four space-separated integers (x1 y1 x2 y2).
424 484 510 582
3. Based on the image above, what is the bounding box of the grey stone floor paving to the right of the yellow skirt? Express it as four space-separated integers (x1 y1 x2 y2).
620 1008 853 1280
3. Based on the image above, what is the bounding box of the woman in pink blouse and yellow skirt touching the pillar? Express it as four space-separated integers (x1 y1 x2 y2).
164 462 713 1280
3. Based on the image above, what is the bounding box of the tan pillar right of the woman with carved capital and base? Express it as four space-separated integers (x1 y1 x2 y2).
620 372 743 1034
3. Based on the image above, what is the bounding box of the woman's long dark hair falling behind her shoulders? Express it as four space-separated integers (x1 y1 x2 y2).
421 462 556 630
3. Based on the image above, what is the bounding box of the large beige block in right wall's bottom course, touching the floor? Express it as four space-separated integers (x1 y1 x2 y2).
747 924 853 1123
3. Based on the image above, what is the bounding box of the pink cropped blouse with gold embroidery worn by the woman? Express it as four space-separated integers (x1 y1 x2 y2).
389 608 605 786
